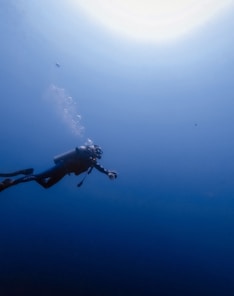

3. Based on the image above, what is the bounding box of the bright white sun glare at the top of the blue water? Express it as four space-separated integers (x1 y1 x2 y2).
70 0 233 42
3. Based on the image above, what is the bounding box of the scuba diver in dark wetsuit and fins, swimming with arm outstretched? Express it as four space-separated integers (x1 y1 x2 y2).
0 145 117 191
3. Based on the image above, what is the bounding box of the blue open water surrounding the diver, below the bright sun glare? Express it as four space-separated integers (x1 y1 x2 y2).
0 0 234 296
